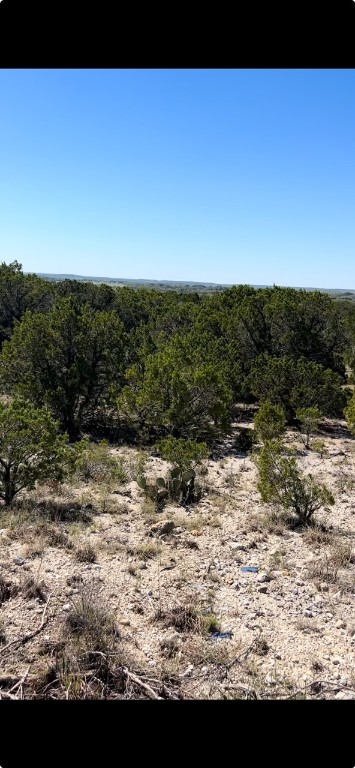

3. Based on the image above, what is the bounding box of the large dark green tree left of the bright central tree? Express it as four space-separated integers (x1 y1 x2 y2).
0 297 124 439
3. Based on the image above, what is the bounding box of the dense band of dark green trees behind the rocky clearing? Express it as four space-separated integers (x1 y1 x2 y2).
0 262 355 443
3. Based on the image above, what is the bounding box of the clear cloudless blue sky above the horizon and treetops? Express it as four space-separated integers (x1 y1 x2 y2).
0 69 355 288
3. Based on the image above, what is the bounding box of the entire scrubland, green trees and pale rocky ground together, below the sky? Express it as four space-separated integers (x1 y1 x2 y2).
0 262 355 699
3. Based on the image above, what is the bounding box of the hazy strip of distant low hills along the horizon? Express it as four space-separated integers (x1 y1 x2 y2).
25 272 355 301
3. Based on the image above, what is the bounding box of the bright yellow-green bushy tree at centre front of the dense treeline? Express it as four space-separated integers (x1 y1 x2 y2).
118 339 232 440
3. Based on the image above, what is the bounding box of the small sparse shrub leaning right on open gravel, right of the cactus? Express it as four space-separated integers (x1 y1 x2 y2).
255 440 335 525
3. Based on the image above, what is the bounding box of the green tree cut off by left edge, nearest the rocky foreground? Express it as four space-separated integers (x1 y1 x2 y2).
0 399 75 505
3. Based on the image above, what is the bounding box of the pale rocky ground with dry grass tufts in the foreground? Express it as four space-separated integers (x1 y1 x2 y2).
0 421 355 699
